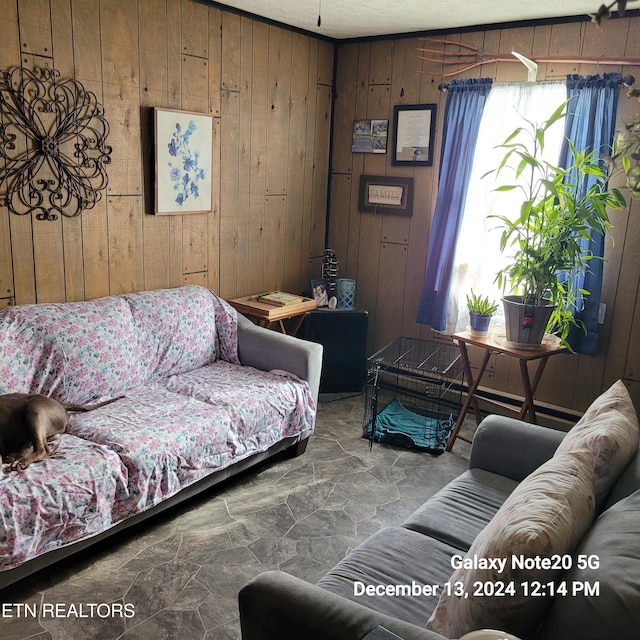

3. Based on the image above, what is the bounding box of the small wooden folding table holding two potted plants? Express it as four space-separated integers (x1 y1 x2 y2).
447 331 566 451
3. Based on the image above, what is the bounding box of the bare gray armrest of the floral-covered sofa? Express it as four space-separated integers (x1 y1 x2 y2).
238 313 322 404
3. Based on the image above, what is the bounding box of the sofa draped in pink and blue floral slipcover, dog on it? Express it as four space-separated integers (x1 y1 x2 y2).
0 286 322 587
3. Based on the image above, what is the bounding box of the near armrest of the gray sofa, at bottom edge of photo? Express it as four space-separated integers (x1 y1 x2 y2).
238 571 445 640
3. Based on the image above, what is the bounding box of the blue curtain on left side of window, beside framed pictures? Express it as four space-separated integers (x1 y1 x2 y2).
417 78 492 331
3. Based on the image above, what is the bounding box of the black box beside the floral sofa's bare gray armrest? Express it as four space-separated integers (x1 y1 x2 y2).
298 305 368 393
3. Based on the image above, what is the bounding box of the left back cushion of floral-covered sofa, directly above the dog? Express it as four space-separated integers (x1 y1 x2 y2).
2 296 145 403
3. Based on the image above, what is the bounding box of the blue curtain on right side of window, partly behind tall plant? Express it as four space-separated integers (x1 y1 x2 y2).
560 73 621 355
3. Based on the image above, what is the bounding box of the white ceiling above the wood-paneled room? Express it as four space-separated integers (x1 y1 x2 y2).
204 0 608 39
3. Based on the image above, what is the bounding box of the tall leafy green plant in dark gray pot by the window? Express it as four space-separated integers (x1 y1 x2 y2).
485 102 626 348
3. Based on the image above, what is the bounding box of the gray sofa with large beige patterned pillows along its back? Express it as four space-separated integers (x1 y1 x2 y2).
239 382 640 640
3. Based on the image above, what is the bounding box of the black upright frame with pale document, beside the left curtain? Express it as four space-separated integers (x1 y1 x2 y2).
391 104 437 167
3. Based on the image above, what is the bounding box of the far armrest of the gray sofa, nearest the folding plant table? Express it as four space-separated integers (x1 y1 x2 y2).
469 415 565 482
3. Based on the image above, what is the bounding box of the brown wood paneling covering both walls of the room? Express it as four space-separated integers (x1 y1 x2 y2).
0 0 640 416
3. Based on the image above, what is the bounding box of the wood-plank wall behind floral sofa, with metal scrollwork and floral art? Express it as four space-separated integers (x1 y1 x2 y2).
0 0 334 308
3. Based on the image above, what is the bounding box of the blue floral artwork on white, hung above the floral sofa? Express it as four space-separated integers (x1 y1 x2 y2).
153 107 213 215
